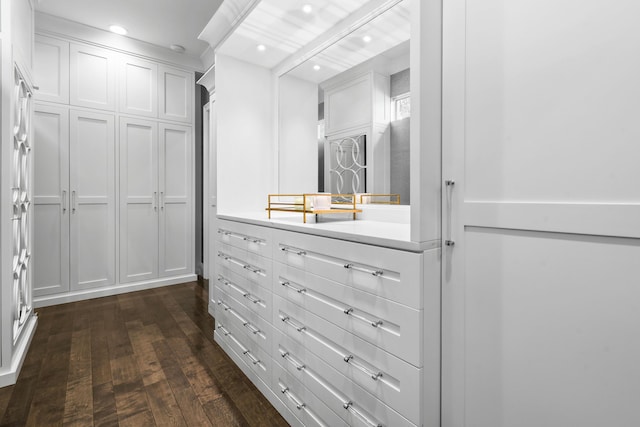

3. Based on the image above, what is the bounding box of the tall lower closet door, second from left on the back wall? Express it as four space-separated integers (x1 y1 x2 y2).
69 111 116 290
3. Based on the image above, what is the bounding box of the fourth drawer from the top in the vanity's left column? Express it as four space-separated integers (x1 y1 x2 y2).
216 288 272 352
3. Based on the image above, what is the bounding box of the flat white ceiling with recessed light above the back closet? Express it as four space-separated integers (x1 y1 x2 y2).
35 0 223 57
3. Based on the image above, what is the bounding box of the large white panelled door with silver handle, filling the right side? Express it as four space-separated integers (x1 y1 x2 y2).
442 0 640 427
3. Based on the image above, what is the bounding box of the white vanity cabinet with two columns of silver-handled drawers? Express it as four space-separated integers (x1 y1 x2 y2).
212 219 425 426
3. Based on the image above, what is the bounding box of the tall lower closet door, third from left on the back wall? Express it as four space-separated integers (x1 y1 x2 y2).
120 117 160 283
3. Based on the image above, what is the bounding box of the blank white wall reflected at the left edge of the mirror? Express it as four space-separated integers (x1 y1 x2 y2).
278 75 318 193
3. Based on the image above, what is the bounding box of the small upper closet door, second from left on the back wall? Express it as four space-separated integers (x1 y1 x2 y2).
69 44 116 111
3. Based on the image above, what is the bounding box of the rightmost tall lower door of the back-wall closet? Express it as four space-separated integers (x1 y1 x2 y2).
159 123 193 276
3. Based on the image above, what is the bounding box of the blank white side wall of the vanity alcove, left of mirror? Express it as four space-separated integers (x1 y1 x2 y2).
216 55 277 216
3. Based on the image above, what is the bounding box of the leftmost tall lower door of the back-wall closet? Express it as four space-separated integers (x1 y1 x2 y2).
33 104 70 297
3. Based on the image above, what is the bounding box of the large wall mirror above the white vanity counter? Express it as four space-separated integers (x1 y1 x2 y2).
278 0 415 205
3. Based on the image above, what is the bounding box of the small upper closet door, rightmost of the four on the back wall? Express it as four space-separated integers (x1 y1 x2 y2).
158 66 194 122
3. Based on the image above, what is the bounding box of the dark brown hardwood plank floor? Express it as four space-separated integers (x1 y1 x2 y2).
0 282 288 427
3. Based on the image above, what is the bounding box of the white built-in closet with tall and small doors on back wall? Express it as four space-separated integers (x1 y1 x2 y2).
34 35 194 305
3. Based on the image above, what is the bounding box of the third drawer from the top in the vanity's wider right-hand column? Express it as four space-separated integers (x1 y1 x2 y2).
271 295 422 425
